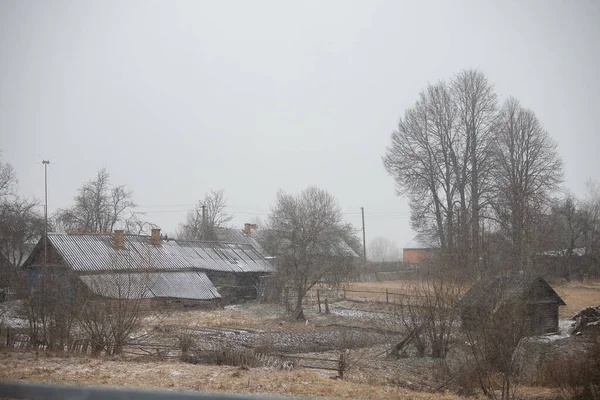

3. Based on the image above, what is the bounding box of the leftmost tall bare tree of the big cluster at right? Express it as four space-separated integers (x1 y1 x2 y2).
383 82 464 253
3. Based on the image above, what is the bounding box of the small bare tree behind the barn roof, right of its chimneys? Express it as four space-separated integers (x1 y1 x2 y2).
177 189 233 240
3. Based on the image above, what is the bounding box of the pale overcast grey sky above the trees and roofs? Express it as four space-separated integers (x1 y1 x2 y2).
0 0 600 253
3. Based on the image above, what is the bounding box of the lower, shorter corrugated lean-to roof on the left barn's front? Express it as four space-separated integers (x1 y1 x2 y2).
79 271 221 300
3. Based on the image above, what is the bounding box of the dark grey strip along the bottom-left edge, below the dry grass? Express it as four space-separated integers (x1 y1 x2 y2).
0 382 310 400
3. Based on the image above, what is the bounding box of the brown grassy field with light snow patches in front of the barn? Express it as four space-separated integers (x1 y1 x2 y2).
0 281 600 400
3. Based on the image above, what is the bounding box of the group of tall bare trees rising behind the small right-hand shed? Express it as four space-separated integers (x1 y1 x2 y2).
383 70 598 273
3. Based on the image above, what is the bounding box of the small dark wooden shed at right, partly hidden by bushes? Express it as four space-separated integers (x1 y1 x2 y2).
459 275 566 336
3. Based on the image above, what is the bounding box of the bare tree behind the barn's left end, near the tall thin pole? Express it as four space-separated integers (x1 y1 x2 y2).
55 168 136 233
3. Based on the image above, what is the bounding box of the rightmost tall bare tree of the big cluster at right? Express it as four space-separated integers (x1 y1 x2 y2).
494 98 562 268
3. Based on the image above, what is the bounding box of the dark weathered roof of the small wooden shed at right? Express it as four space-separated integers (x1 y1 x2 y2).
459 275 565 310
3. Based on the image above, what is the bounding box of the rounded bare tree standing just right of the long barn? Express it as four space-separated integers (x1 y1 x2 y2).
264 187 358 320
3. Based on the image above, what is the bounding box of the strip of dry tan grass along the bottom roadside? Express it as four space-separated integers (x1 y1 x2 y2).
0 352 460 400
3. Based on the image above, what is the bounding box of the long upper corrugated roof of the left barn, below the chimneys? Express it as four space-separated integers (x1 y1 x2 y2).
48 233 274 272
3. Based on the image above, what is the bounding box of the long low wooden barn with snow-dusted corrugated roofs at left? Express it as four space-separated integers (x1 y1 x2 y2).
23 229 272 302
